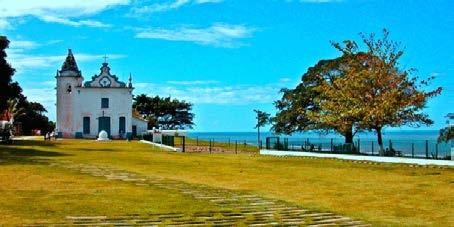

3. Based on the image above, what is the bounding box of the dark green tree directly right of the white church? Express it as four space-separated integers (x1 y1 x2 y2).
133 94 194 129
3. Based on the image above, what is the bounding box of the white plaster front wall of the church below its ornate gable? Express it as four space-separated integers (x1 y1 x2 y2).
73 87 132 138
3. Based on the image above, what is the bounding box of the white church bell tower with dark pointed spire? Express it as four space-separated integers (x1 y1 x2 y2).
56 49 83 137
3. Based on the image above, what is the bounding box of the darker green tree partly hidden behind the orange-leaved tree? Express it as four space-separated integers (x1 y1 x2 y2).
273 55 364 143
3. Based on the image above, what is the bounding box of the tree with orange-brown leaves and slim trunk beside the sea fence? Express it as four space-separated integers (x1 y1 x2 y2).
323 30 441 154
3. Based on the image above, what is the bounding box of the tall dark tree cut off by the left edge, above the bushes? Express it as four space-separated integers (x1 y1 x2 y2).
0 36 21 113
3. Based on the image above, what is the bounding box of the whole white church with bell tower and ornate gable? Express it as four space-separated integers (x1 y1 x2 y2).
56 49 147 138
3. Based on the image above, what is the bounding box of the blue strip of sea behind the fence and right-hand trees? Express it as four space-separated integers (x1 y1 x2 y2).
188 130 451 158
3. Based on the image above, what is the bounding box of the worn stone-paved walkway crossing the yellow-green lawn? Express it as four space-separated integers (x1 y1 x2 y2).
26 162 370 226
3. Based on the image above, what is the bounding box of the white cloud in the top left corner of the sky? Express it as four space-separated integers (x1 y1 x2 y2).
0 0 130 28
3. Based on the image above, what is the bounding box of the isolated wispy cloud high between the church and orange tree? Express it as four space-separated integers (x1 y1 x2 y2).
135 24 255 47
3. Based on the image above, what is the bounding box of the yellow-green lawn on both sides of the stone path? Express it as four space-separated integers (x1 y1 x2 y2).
0 140 454 226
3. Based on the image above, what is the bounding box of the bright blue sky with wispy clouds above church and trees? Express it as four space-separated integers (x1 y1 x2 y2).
0 0 454 131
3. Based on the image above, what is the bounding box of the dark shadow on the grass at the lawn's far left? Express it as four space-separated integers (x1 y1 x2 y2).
0 141 68 165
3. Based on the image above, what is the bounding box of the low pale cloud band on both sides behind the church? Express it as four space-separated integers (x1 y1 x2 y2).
23 77 288 120
